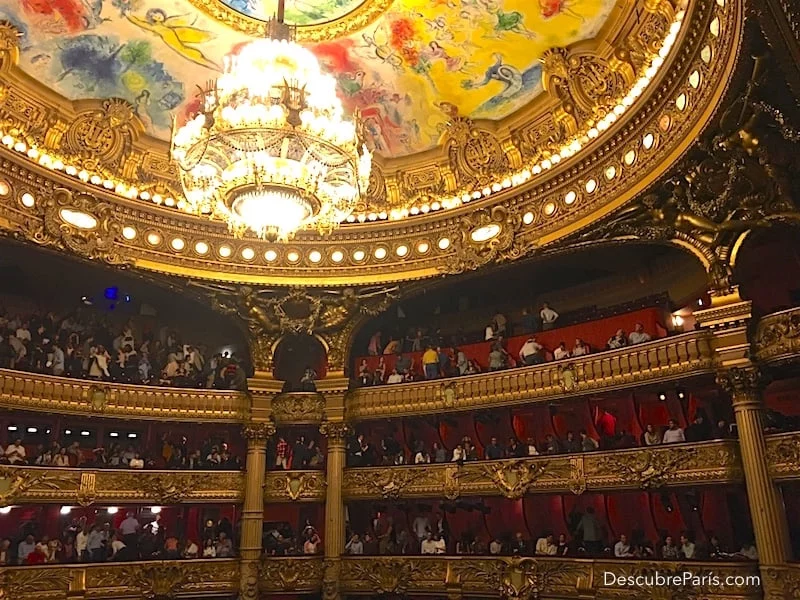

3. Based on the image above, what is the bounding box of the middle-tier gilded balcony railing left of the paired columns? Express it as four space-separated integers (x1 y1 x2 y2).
0 465 244 506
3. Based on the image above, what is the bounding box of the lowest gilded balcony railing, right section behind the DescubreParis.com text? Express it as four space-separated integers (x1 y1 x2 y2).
339 556 760 600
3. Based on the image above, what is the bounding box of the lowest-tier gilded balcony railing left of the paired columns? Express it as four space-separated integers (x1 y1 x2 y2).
0 559 239 600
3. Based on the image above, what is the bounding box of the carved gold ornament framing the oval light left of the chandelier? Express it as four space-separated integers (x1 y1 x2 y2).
14 188 130 265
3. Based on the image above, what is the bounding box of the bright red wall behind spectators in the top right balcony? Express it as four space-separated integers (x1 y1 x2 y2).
355 308 666 375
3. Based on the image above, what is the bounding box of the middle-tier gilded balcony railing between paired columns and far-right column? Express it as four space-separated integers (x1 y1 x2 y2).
342 440 744 500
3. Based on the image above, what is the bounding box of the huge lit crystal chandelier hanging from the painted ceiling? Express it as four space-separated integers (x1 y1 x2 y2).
172 1 372 241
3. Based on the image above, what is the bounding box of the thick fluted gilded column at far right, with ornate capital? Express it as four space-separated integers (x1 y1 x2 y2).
717 367 791 566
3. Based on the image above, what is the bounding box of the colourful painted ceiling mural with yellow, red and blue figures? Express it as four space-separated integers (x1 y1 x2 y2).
0 0 616 156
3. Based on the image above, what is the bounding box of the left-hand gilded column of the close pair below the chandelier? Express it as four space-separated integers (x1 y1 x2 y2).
239 422 275 600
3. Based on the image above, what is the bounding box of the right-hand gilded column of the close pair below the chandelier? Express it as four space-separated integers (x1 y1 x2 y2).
319 421 348 600
